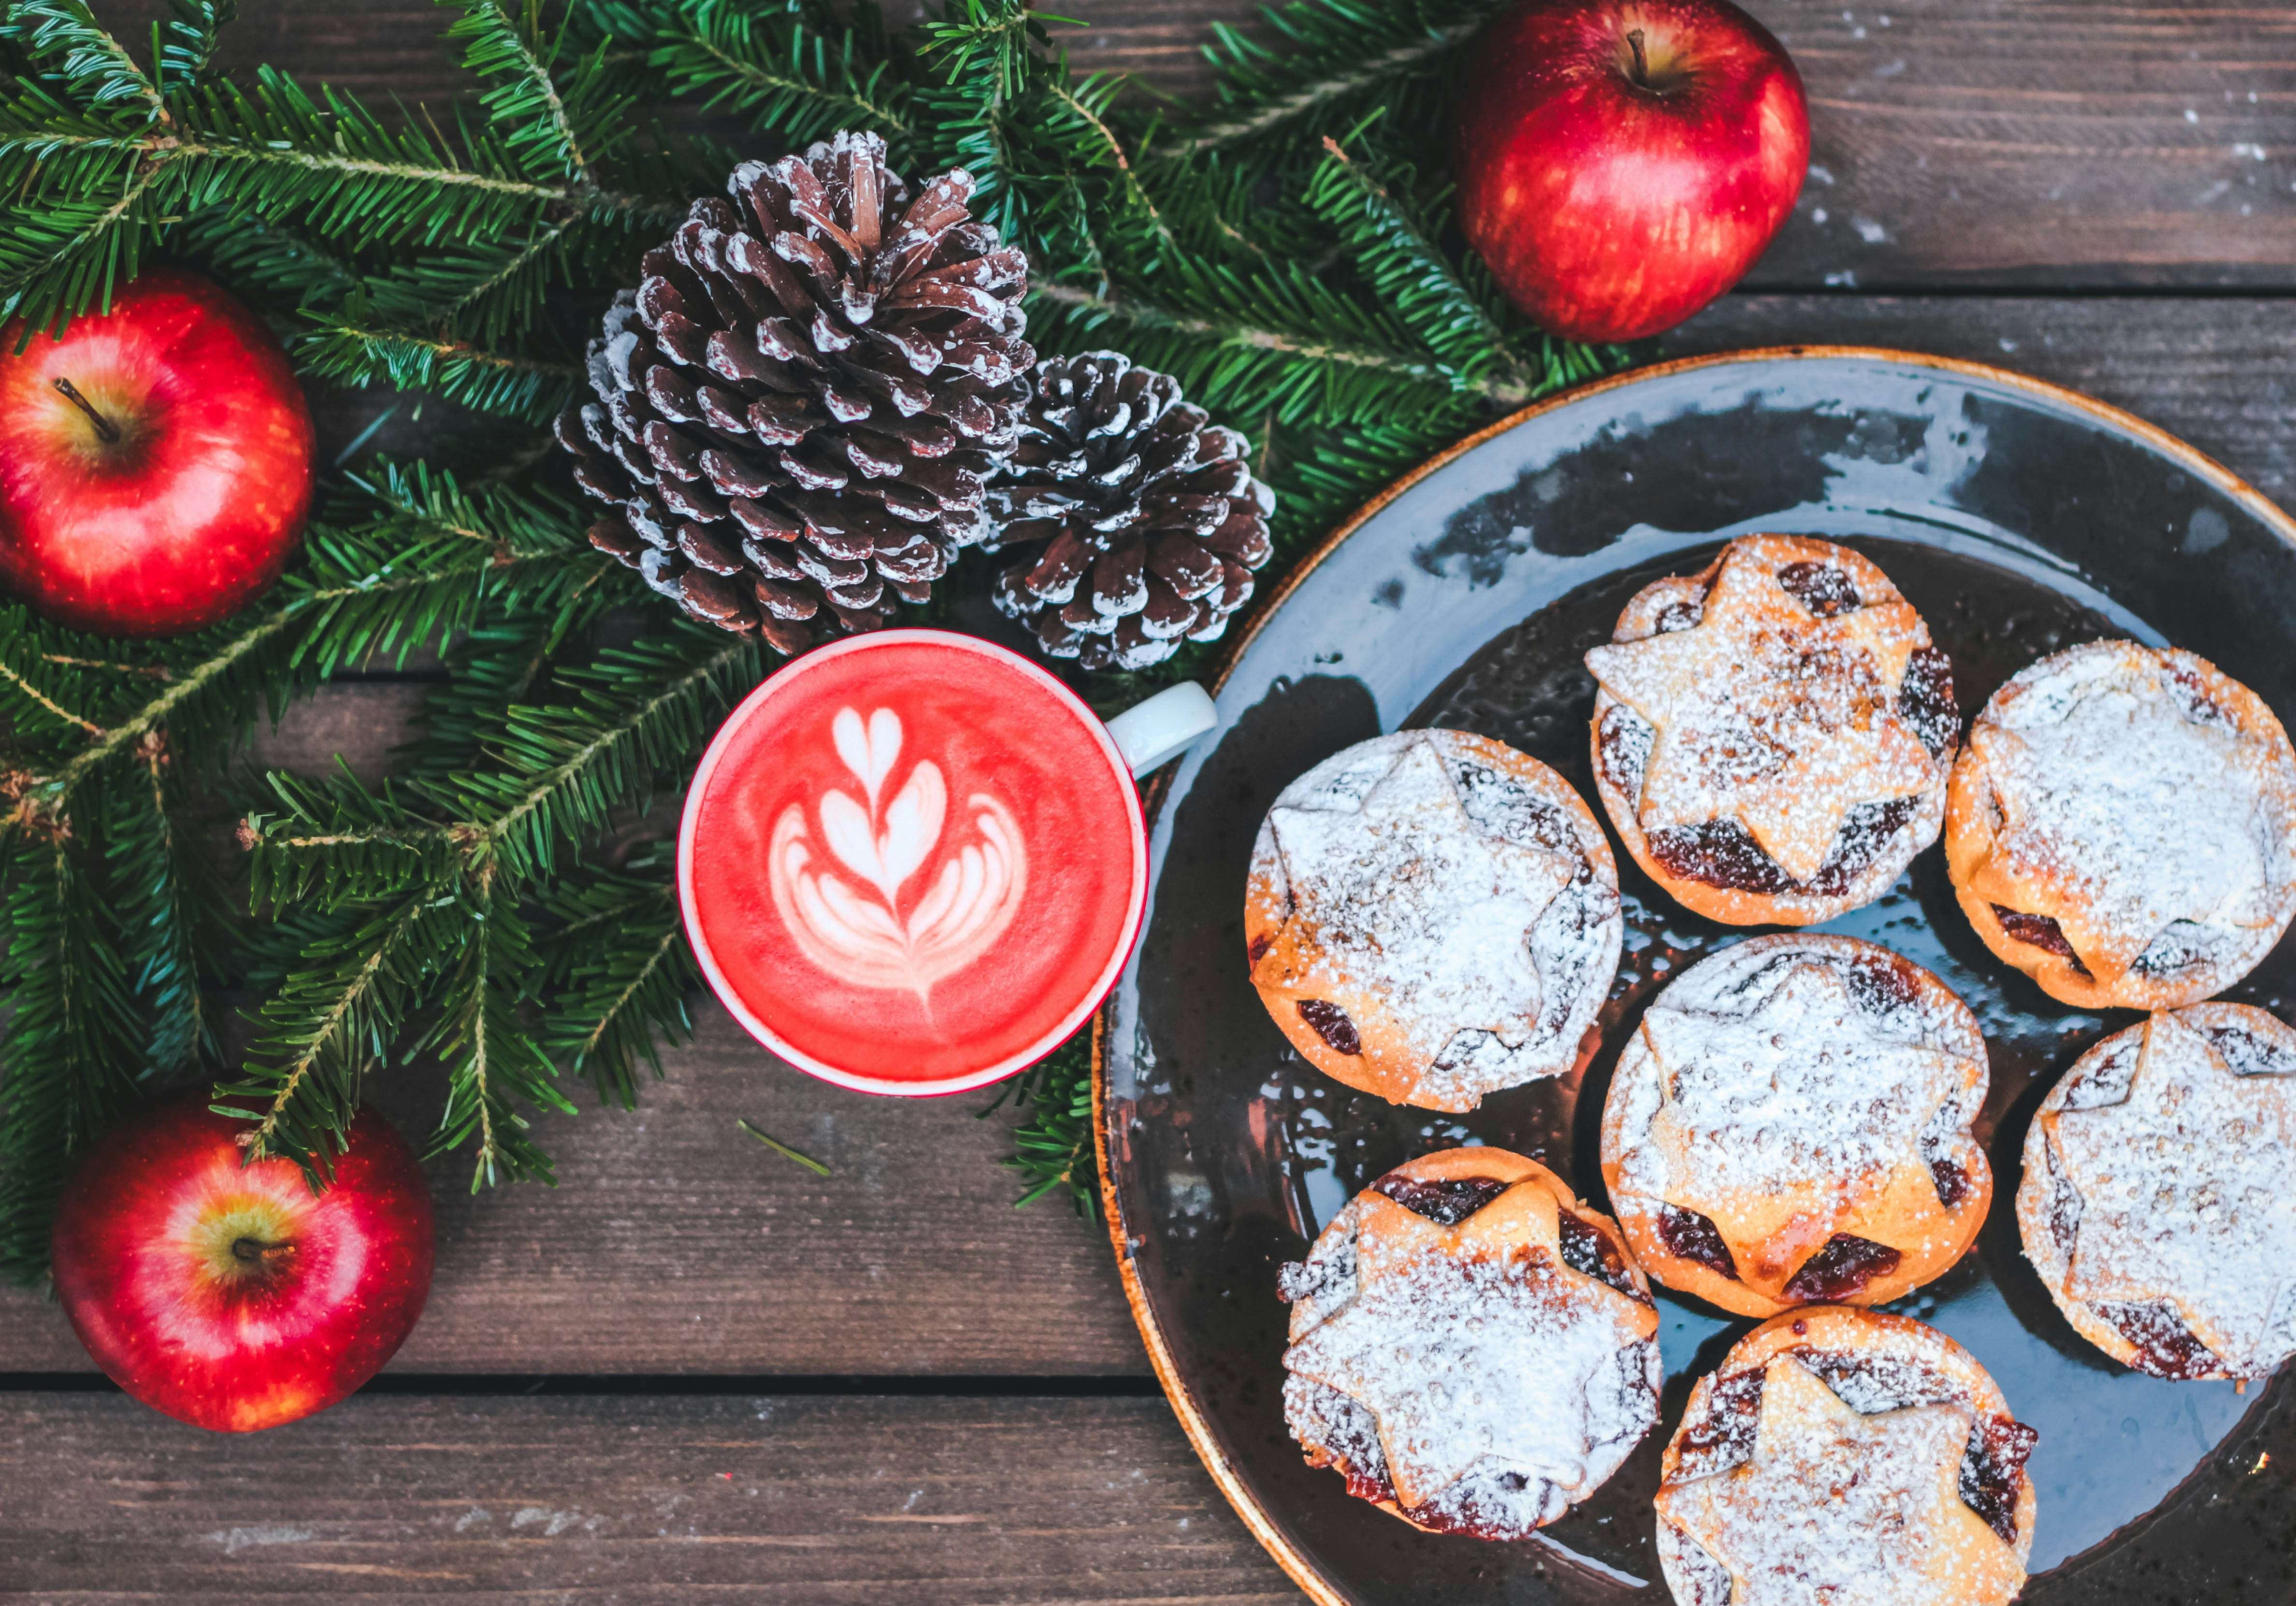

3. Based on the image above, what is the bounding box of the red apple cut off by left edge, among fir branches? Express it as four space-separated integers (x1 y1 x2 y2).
0 269 312 636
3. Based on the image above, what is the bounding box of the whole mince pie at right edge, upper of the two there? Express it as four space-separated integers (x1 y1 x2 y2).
1945 640 2296 1009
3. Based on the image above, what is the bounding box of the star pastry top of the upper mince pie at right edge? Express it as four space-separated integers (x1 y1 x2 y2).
1970 654 2284 984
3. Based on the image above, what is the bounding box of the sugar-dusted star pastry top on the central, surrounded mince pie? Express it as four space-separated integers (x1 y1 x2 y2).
1619 959 1982 1280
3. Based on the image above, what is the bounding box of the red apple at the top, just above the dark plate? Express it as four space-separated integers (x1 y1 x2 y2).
1455 0 1809 340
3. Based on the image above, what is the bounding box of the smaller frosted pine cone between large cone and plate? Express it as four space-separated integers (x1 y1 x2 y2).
987 351 1277 670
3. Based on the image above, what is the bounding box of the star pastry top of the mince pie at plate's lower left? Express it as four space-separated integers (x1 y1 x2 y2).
1283 1181 1658 1510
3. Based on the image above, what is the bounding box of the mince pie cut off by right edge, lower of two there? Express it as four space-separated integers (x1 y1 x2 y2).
2016 1003 2296 1379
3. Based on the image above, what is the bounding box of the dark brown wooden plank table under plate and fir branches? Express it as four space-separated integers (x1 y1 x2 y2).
0 0 2296 1606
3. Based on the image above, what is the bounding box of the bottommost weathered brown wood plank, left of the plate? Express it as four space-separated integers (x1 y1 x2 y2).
0 1395 1297 1606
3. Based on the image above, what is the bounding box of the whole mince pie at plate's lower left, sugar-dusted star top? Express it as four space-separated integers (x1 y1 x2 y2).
1279 1150 1660 1539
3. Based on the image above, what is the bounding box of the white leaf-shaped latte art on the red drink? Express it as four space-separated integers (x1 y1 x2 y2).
769 709 1028 1012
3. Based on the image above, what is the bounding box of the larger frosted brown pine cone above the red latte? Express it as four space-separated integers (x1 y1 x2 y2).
558 133 1036 652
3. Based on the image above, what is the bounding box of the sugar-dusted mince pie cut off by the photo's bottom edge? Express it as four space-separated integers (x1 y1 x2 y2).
1658 1306 2039 1606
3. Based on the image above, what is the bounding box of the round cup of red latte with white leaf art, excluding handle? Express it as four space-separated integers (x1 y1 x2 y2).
677 631 1148 1094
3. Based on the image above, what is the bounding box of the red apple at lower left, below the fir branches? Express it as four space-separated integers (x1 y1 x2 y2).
53 1090 432 1434
